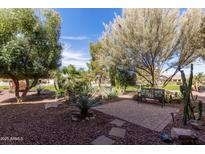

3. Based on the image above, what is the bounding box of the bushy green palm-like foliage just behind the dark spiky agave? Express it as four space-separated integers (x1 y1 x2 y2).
53 65 90 102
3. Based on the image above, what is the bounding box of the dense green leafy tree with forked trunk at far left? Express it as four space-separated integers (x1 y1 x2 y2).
0 9 61 102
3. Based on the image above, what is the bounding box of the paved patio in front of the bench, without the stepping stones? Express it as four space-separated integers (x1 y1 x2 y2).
95 100 179 132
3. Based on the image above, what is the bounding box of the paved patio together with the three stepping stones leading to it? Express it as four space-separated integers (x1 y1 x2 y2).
91 100 179 145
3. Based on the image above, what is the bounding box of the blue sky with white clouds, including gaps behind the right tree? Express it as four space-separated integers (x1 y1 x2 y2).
55 8 205 74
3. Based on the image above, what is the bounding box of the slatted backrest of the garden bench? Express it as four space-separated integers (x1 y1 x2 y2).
141 88 165 98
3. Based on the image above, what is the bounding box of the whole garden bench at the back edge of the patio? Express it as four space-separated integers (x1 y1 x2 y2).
138 88 165 107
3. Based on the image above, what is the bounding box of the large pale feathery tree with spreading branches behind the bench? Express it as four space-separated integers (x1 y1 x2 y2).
99 9 202 87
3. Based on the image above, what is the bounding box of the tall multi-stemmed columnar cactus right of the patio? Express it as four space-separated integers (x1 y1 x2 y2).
179 64 195 125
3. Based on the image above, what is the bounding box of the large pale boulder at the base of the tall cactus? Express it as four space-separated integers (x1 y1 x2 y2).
171 128 196 139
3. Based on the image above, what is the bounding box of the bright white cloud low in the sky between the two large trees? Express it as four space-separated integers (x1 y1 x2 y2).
62 44 90 69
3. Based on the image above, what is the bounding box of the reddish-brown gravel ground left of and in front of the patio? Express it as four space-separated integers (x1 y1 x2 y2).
0 90 167 145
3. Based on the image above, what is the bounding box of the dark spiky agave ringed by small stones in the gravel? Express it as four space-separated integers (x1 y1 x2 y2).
76 95 99 119
